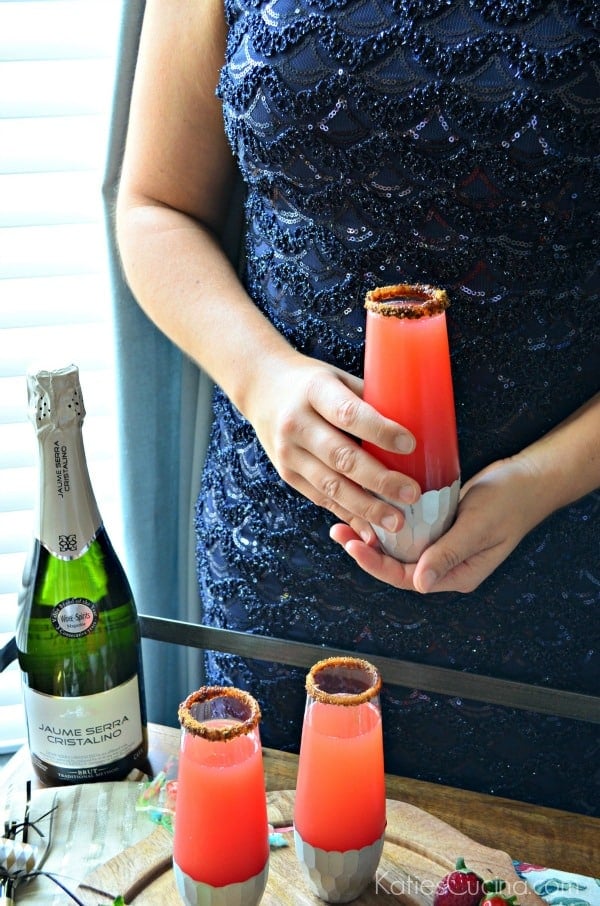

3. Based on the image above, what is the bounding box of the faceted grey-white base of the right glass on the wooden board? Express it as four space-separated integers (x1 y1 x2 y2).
294 830 385 903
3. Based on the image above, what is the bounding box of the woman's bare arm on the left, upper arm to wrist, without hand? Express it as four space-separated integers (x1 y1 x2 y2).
116 0 300 412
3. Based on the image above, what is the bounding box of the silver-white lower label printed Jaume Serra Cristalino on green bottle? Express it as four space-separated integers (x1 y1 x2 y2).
23 676 143 769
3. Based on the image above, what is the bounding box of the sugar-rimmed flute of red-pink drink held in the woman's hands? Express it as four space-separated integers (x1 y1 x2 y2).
363 284 460 563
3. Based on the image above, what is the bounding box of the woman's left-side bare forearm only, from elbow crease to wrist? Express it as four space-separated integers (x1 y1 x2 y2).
117 197 300 414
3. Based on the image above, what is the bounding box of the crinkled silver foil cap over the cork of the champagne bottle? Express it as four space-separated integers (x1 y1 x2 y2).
27 365 85 432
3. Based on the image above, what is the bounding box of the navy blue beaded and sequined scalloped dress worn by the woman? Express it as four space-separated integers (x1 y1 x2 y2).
196 0 600 814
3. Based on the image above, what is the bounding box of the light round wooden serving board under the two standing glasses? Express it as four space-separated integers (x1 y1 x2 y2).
77 790 544 906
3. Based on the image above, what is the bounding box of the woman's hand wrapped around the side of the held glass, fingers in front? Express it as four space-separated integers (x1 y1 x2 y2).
241 349 420 540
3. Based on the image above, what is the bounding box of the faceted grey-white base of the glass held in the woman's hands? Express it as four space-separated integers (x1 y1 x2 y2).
373 478 460 563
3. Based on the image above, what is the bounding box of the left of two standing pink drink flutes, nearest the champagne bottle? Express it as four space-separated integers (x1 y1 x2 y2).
173 686 269 906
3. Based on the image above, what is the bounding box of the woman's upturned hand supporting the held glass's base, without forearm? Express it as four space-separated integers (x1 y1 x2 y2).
330 458 546 593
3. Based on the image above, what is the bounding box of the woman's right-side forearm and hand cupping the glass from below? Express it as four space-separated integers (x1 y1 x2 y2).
330 394 600 593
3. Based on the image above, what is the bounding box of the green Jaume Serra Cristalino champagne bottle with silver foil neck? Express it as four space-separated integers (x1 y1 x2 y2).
16 365 147 785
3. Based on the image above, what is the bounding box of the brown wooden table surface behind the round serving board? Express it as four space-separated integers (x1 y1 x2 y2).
0 724 600 876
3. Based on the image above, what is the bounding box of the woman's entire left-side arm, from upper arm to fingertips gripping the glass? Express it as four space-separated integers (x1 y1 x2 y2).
117 0 418 531
